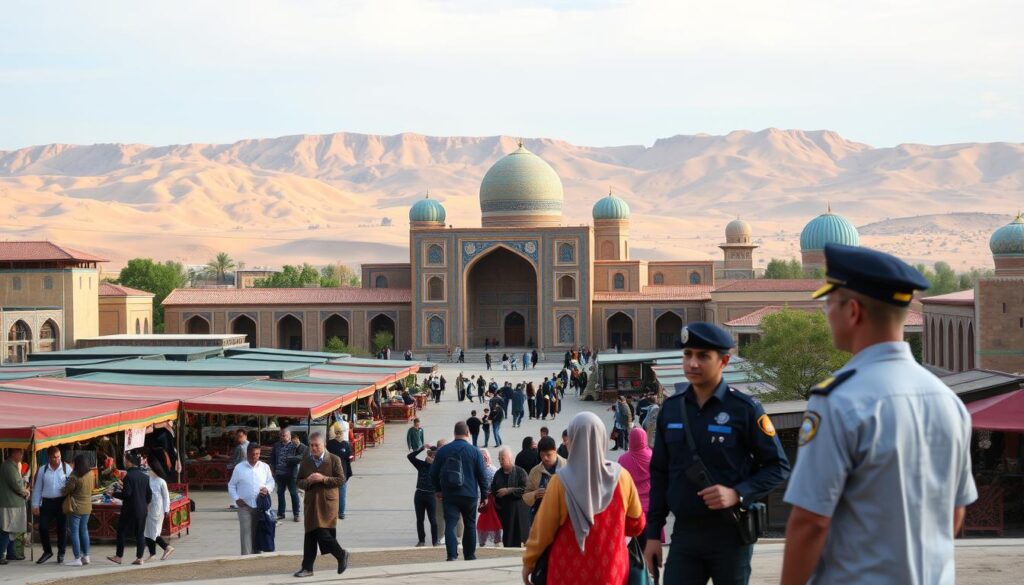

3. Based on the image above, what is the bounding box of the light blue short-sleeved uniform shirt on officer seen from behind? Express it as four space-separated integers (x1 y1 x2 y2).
784 342 978 585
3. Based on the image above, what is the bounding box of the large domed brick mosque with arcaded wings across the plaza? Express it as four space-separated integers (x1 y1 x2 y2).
164 142 880 356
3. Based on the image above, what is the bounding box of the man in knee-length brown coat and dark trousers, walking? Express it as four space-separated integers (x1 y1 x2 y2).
295 432 348 577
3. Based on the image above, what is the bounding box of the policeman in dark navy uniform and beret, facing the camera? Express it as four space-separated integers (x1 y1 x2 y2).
645 323 790 585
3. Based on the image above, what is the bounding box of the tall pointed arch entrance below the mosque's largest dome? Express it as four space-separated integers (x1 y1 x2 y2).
463 246 542 347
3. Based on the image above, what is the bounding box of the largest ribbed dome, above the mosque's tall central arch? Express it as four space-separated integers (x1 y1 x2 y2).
480 143 563 226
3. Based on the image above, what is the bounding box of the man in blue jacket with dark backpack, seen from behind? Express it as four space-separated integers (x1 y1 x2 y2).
430 421 487 560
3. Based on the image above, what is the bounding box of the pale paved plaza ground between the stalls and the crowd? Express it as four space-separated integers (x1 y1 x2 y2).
0 364 1024 585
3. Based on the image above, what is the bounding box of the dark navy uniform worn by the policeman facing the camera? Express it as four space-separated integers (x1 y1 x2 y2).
647 380 790 585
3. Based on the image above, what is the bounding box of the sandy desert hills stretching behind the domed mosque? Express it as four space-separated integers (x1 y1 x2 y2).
0 128 1024 269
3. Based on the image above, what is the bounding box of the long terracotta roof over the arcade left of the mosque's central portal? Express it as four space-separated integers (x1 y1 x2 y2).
163 287 413 306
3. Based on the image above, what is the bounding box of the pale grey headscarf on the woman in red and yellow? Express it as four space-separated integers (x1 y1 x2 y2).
558 412 622 552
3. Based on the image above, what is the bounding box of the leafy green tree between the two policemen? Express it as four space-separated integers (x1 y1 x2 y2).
743 308 850 402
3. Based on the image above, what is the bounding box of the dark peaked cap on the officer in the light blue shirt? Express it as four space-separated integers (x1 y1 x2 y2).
811 244 930 306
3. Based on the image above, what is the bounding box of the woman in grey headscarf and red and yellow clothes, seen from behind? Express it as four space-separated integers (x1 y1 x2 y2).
522 412 646 585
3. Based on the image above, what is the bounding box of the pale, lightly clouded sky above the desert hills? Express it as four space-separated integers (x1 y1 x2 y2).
0 0 1024 150
